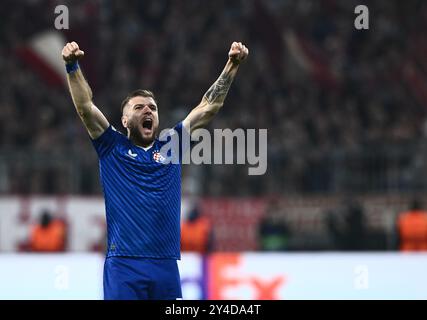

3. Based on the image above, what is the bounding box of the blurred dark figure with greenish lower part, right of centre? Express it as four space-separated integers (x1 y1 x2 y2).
258 202 290 251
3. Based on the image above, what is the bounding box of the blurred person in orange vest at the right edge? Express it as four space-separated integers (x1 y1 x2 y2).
397 199 427 251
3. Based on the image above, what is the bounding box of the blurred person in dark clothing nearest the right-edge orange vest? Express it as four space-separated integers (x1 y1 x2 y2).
327 200 370 251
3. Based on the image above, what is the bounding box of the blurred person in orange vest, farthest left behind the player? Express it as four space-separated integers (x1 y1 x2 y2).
30 210 66 252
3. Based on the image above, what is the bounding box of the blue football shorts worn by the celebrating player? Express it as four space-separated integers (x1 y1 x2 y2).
104 257 182 300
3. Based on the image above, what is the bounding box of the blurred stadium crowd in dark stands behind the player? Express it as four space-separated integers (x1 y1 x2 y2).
0 0 427 196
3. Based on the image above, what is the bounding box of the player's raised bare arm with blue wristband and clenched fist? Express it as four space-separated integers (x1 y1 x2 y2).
62 42 110 139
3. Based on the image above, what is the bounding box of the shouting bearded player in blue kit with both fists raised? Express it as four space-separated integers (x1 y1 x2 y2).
62 42 249 300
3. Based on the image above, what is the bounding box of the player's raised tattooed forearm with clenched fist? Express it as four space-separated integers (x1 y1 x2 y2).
183 42 249 132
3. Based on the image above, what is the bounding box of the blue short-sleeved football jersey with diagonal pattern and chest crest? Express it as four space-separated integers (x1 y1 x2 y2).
92 122 186 259
